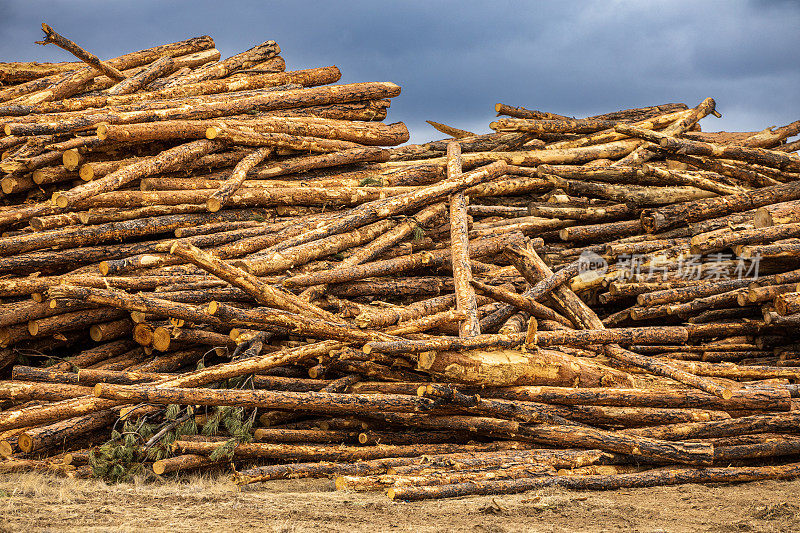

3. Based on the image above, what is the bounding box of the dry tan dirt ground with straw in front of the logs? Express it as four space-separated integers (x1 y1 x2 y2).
0 474 800 533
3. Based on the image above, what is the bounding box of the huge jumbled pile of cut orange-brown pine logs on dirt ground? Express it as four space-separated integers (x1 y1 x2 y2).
0 25 800 500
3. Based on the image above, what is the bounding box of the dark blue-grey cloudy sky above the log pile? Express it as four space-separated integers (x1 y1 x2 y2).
0 0 800 142
